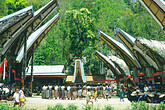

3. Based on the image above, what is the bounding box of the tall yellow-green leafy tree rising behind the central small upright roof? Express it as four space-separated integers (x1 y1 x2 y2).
66 8 95 58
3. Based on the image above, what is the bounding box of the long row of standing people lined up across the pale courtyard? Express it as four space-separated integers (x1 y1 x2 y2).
42 84 113 100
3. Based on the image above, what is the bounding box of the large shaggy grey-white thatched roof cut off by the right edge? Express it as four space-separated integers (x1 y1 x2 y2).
134 38 165 70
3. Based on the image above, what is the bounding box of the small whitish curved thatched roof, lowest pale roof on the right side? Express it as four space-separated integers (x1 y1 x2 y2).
109 55 130 76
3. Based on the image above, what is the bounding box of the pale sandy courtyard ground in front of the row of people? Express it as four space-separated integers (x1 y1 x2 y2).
24 96 131 110
